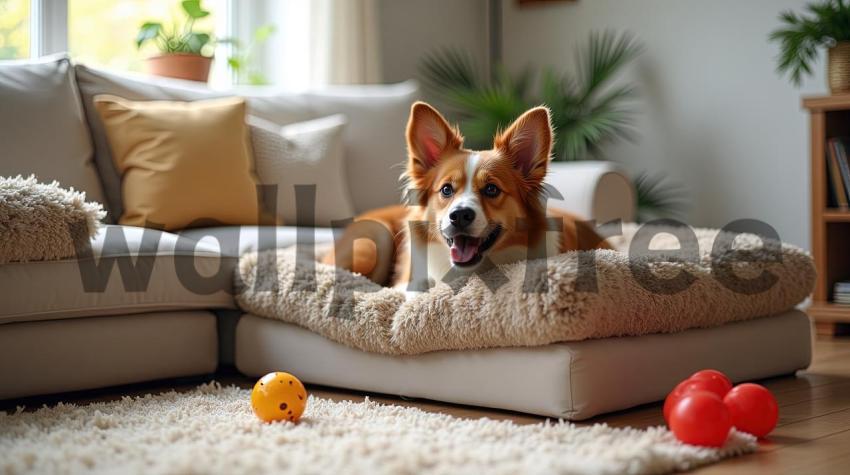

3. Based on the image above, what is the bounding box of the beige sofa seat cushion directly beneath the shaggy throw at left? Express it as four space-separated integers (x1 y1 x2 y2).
0 226 235 324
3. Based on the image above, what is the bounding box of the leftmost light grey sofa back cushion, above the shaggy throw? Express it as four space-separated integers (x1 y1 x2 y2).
0 56 104 206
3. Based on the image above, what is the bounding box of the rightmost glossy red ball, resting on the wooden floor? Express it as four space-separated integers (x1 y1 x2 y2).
723 383 779 437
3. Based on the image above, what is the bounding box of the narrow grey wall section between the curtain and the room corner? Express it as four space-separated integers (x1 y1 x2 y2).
378 0 487 82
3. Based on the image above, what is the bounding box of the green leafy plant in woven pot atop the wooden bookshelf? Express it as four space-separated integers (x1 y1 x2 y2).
770 0 850 94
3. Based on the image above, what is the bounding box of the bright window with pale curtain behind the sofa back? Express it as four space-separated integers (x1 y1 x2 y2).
0 0 356 89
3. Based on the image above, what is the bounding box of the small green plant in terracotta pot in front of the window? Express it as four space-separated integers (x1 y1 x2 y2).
136 0 213 82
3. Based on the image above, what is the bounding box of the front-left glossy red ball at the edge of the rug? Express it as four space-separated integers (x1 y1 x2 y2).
670 391 732 447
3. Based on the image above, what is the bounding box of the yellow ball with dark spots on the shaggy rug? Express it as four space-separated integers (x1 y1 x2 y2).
251 371 307 422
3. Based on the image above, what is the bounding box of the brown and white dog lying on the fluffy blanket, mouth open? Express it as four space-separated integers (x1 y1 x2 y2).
323 102 608 289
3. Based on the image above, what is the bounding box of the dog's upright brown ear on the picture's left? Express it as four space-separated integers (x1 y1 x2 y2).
407 102 463 176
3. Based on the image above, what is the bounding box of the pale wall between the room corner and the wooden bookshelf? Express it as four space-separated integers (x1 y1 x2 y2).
503 0 826 247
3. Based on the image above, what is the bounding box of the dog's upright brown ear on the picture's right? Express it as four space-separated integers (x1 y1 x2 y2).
493 107 552 183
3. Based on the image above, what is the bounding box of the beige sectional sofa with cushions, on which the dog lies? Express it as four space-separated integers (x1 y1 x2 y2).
0 55 811 419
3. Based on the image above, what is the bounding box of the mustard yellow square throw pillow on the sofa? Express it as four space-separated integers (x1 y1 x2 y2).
94 95 260 230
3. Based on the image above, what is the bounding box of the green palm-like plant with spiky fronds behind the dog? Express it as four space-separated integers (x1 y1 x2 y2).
420 32 684 220
